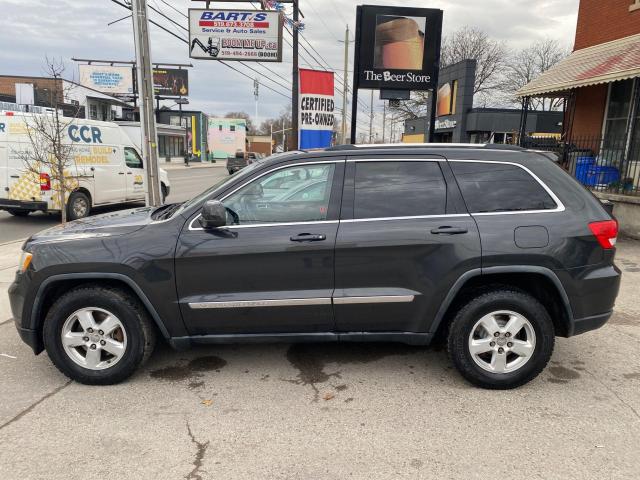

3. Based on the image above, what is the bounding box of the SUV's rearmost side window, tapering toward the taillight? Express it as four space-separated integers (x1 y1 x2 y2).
451 161 558 213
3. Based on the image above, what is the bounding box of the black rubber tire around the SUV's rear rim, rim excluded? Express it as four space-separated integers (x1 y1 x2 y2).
447 288 555 390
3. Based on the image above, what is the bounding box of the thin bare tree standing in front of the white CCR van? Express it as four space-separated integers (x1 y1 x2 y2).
17 57 80 224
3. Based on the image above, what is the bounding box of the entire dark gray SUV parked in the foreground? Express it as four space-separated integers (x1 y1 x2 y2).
9 145 620 388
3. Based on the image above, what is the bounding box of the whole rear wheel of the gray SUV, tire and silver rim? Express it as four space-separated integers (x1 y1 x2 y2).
448 289 555 389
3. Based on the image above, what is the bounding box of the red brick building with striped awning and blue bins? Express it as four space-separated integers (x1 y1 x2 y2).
518 0 640 235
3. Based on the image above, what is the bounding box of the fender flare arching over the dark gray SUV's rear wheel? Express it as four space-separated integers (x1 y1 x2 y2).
431 265 575 337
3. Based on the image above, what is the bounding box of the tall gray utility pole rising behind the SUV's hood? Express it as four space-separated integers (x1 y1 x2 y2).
131 0 162 206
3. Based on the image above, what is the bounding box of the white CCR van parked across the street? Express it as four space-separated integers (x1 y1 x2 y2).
0 112 170 220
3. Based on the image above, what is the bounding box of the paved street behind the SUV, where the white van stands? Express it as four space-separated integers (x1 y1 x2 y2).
0 166 228 243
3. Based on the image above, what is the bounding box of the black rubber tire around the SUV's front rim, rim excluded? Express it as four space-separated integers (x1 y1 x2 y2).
43 285 156 385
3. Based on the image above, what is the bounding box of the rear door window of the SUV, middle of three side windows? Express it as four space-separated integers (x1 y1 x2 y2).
354 161 447 219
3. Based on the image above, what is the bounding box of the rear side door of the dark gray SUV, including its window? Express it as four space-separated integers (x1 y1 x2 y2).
333 156 481 334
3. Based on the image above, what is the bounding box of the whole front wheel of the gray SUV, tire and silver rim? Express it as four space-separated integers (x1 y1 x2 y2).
43 286 156 385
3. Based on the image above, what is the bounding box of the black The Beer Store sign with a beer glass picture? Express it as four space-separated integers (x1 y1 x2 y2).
355 5 442 90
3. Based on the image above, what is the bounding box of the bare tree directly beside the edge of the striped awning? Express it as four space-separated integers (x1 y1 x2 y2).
503 38 569 110
